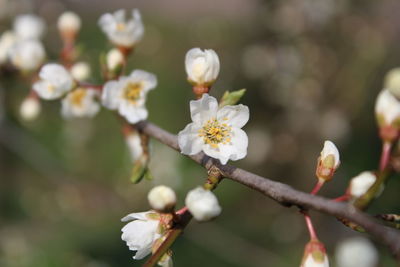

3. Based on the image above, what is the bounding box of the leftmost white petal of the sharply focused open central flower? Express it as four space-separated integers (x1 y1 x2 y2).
178 123 204 155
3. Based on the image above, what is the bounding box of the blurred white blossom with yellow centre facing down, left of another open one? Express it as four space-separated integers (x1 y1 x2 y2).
61 88 100 118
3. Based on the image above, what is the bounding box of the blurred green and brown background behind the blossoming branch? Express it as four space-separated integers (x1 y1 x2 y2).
0 0 400 267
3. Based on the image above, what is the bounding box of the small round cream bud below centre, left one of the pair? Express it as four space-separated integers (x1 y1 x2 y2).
147 185 176 212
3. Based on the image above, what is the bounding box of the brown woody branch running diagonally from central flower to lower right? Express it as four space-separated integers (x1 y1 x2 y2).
136 121 400 262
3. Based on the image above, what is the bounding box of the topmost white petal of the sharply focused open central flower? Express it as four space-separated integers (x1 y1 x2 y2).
190 94 218 125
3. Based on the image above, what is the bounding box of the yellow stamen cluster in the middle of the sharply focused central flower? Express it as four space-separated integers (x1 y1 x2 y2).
199 118 232 148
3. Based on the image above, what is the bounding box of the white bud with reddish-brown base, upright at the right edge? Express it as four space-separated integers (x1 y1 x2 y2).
375 89 400 142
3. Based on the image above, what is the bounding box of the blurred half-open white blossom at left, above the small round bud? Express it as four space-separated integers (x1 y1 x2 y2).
33 64 74 100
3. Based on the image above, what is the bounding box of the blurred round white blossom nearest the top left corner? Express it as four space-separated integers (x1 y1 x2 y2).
14 14 45 39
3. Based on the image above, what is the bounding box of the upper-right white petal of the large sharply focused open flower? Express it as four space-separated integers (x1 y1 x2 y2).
217 104 250 128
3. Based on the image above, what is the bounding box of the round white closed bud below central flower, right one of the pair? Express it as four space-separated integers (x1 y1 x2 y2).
185 187 221 222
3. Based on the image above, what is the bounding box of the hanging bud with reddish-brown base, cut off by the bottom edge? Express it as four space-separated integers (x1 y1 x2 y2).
300 239 329 267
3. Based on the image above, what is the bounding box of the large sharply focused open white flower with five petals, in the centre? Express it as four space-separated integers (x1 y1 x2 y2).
178 94 249 164
